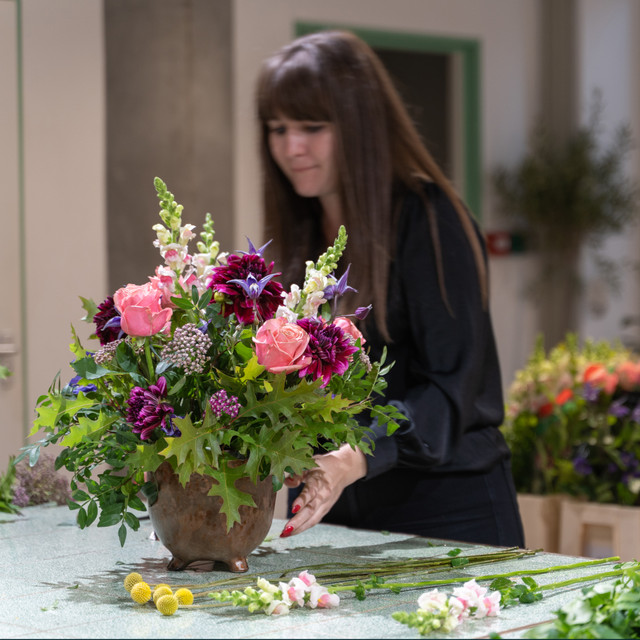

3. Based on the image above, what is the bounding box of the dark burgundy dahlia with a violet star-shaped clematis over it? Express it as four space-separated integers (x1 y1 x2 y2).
209 252 282 324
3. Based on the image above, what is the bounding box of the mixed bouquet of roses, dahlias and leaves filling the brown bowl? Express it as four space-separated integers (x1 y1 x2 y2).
18 178 402 544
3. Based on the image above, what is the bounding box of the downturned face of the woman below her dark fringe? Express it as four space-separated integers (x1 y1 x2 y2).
267 117 338 202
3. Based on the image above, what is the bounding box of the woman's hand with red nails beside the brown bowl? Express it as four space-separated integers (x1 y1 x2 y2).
280 444 367 538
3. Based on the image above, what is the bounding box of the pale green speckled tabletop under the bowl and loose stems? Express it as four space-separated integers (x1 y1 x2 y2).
0 505 610 638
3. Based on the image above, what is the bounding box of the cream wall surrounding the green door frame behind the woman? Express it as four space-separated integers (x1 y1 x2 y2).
233 0 540 390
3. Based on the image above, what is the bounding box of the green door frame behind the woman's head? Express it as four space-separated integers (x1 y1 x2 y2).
295 22 482 219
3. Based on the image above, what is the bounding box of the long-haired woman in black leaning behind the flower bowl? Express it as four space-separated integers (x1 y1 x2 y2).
257 32 524 546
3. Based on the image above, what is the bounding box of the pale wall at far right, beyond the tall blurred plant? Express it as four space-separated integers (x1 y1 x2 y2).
578 0 640 348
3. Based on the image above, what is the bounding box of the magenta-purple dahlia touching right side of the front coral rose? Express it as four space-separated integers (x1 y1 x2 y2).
298 318 358 387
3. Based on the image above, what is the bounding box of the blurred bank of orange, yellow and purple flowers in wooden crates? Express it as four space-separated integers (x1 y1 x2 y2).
502 334 640 505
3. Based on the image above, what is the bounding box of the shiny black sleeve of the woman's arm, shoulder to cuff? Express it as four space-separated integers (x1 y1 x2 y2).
366 184 503 478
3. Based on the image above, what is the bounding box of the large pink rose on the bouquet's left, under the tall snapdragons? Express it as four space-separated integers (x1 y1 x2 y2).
113 282 173 337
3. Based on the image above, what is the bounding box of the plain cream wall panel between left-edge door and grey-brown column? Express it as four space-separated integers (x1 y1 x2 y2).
22 0 106 438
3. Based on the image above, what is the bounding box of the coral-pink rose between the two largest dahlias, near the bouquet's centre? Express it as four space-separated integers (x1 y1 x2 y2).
253 317 311 373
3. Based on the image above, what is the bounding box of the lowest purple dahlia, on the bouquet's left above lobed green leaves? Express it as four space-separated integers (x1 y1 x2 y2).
127 377 181 440
